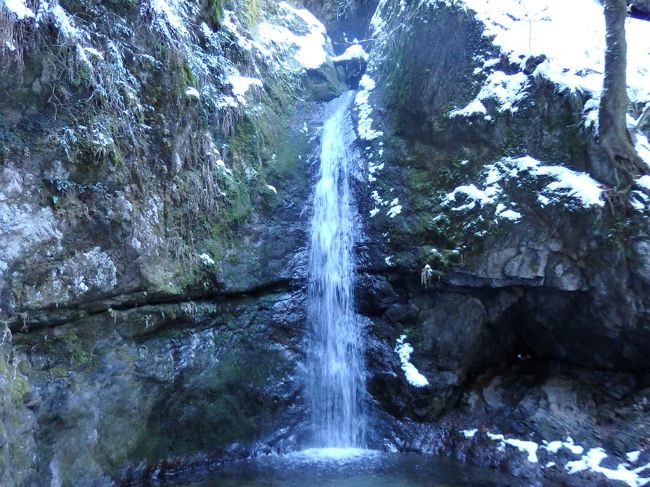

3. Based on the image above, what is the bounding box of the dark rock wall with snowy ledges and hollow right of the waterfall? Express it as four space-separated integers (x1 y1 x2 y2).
357 2 650 482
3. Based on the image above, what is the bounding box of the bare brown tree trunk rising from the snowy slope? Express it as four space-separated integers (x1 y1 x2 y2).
598 0 647 189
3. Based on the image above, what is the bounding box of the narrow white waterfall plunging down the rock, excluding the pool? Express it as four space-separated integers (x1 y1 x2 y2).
307 92 365 447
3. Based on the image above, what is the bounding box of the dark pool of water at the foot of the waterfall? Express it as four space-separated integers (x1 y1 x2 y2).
179 449 530 487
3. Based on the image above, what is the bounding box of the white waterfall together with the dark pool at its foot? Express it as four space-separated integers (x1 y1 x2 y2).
175 93 525 487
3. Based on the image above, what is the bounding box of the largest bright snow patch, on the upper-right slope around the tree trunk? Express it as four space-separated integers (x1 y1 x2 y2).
438 0 650 130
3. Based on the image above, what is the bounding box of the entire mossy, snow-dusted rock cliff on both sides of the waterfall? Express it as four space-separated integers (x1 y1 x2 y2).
0 0 650 485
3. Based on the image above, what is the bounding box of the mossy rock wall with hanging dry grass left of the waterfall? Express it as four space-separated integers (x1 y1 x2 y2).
0 1 345 486
